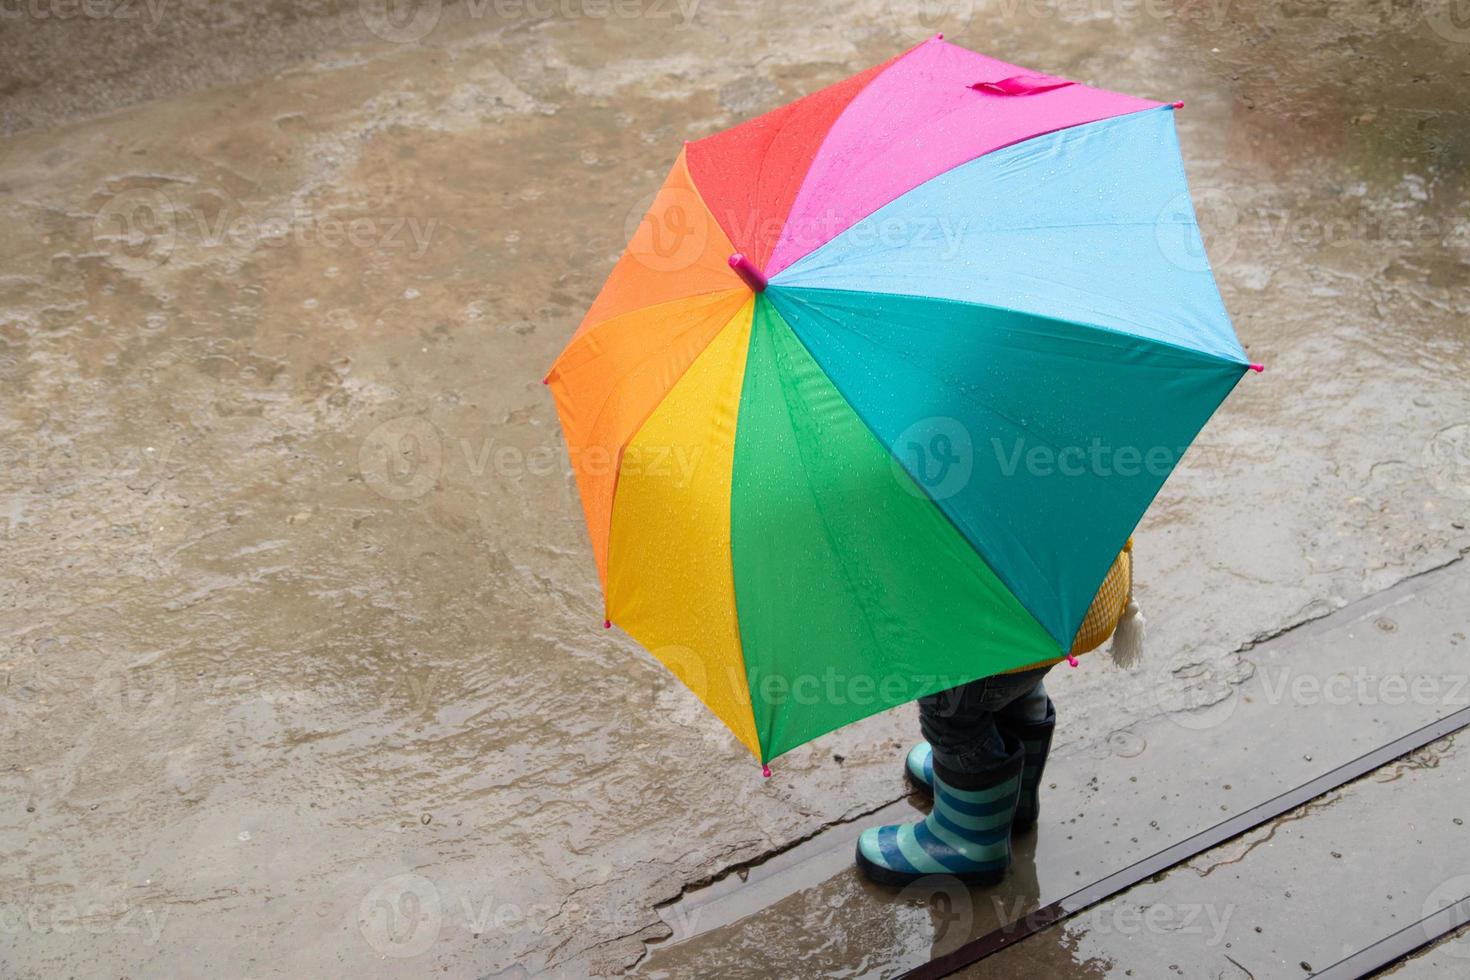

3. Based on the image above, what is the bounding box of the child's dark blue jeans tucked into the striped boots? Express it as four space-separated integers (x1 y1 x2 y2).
919 667 1051 774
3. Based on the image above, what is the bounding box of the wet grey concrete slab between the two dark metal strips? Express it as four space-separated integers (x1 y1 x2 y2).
956 725 1470 980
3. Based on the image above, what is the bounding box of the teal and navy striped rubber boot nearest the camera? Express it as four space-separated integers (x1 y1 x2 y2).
857 739 1023 884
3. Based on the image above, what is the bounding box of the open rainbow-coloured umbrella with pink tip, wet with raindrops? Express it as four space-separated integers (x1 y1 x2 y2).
547 37 1252 774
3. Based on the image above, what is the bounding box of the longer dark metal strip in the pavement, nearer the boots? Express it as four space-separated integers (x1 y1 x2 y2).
900 708 1470 980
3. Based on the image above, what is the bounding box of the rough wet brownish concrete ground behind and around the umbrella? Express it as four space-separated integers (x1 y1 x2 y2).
0 0 1470 977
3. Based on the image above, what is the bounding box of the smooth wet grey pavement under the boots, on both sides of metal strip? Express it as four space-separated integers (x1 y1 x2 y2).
638 561 1470 977
